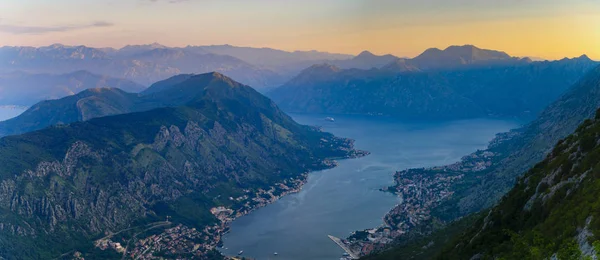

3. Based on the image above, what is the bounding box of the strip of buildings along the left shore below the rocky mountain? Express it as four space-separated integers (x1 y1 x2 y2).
96 143 370 259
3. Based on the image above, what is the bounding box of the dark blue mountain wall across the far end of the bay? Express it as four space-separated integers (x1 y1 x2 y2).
269 57 598 119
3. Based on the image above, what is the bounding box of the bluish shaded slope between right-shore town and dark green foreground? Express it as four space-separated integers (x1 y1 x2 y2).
452 64 600 212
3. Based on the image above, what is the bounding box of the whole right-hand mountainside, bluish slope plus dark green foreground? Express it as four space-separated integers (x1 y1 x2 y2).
368 64 600 259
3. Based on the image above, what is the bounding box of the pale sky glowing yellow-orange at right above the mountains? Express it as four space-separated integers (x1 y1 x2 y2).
0 0 600 60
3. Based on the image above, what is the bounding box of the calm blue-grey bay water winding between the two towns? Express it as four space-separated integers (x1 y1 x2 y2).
222 115 518 260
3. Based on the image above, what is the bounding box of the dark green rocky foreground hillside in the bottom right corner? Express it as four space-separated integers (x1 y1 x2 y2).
439 111 600 259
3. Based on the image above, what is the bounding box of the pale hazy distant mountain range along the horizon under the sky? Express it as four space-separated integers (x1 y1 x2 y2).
0 43 528 96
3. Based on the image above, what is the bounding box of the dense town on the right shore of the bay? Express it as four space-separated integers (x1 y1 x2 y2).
342 145 498 257
